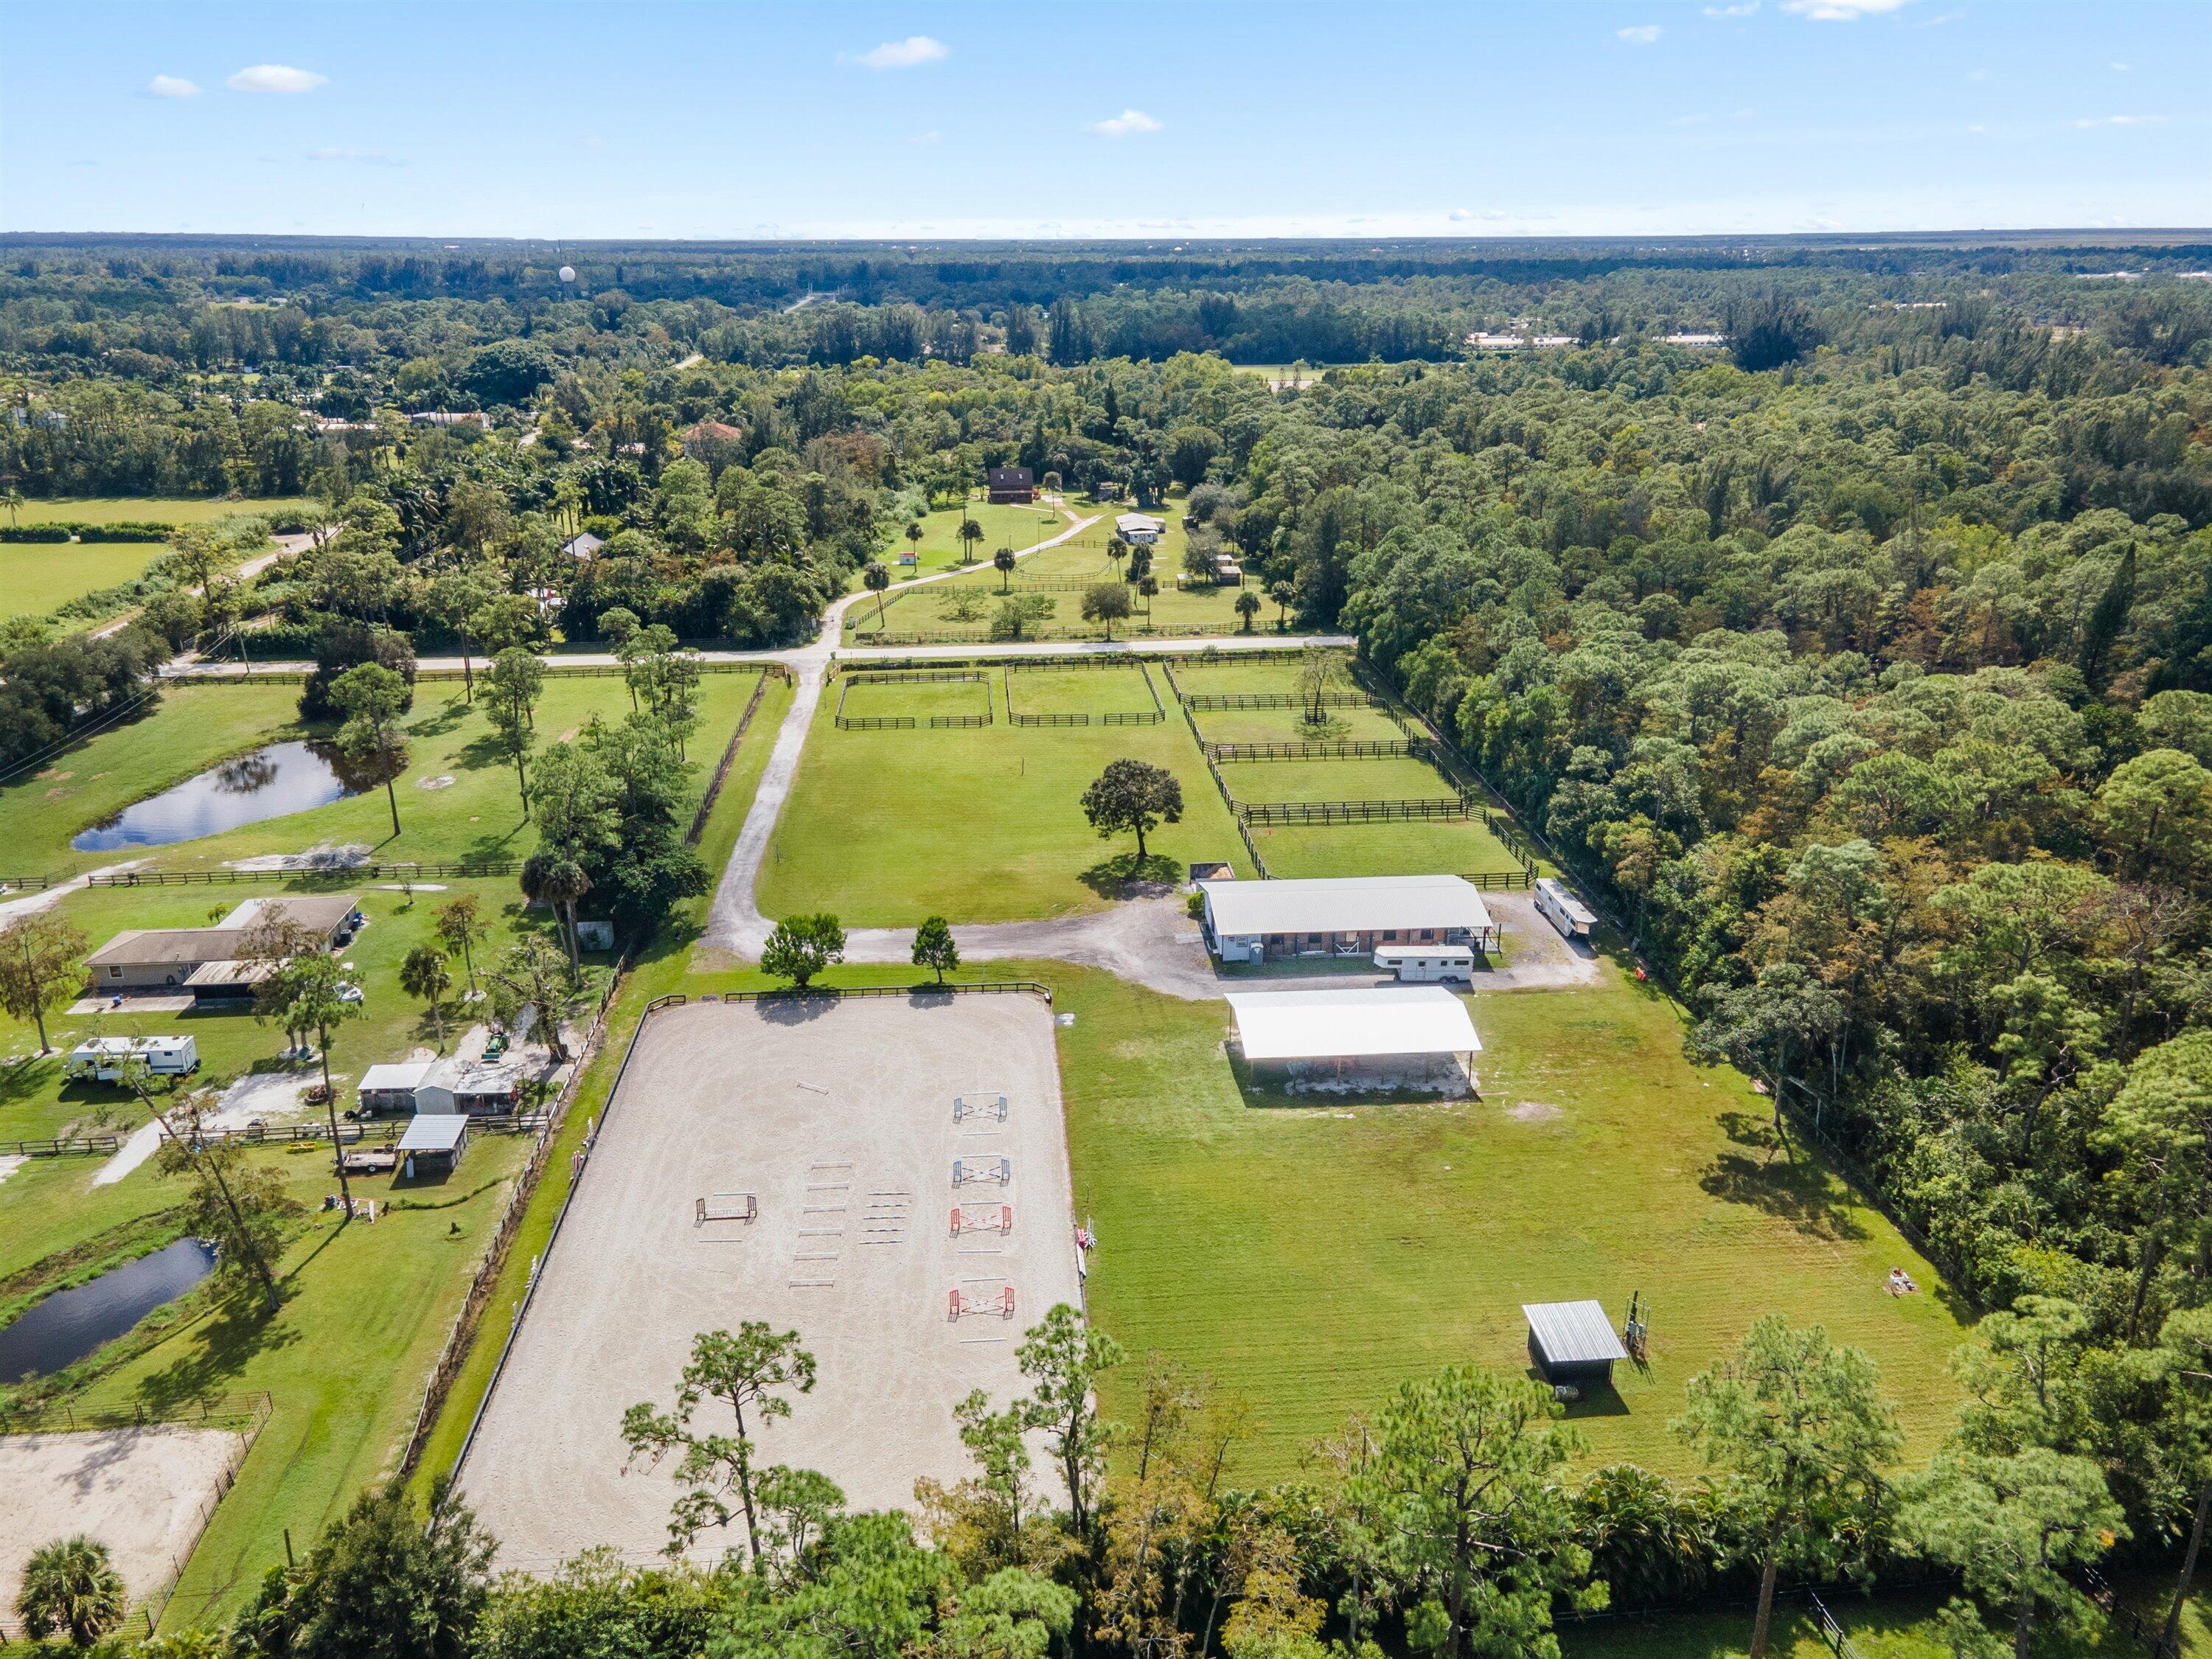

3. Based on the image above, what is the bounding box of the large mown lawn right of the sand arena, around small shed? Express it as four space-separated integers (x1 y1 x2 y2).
1053 969 1962 1478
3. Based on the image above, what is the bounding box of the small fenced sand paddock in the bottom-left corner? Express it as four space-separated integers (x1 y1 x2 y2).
0 1425 241 1626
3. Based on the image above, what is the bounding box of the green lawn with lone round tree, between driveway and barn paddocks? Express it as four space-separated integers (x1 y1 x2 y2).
759 675 1254 927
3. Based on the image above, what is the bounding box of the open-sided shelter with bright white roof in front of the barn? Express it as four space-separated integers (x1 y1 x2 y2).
1230 984 1482 1093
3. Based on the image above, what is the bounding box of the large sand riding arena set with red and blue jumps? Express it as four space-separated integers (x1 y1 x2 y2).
460 995 1077 1571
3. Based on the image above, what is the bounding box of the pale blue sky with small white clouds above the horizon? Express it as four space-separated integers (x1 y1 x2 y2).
0 0 2212 239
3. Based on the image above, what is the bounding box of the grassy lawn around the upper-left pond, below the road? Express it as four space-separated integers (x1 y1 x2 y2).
0 672 754 889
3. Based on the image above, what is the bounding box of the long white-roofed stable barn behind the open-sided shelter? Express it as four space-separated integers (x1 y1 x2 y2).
1199 876 1498 962
